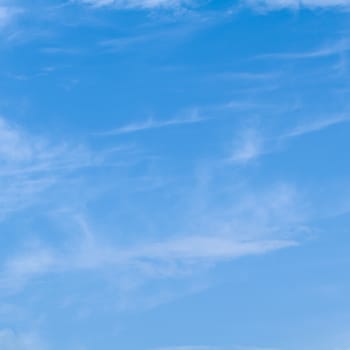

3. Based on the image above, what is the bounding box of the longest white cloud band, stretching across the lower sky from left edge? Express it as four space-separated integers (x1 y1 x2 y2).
0 182 299 289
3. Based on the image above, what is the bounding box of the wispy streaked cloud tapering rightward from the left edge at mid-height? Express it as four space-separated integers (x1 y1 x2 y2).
0 118 131 219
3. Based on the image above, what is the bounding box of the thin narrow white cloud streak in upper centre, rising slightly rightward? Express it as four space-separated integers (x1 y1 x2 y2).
97 110 207 136
